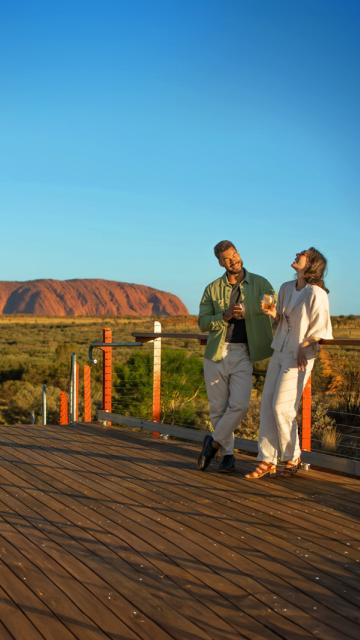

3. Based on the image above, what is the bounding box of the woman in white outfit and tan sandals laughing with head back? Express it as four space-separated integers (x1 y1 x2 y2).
245 247 332 480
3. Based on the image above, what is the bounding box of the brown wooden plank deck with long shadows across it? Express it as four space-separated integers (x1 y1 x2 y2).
0 426 360 640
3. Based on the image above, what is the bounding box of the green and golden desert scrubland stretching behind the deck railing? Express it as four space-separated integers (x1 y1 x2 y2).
0 316 360 457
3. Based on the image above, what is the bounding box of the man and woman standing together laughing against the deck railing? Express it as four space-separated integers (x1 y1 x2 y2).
198 240 332 480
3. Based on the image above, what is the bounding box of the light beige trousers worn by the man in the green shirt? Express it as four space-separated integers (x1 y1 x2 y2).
204 343 253 455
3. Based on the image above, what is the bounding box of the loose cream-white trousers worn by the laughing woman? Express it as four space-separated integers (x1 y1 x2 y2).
257 351 315 464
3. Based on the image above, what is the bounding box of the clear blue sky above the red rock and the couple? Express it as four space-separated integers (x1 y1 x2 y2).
0 0 360 314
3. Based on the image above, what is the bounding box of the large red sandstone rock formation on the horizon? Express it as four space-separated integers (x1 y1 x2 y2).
0 278 189 317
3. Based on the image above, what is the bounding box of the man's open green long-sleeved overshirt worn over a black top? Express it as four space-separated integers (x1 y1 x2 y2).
199 271 274 362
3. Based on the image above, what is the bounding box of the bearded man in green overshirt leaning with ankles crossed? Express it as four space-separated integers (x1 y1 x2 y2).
198 240 274 473
